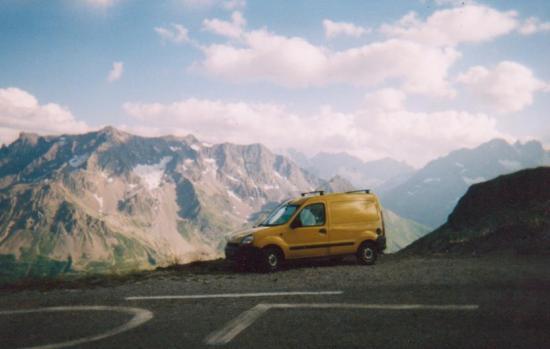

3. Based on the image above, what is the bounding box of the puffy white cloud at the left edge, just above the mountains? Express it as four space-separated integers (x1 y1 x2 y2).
0 87 88 143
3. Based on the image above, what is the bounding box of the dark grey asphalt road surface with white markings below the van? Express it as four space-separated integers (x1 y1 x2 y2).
0 255 550 349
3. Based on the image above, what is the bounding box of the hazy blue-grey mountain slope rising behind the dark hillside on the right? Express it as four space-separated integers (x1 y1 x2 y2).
380 139 550 227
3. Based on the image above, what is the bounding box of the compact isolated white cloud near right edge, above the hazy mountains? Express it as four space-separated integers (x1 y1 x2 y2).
457 61 550 113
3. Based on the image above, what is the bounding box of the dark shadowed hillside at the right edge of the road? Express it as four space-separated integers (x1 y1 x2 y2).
403 167 550 254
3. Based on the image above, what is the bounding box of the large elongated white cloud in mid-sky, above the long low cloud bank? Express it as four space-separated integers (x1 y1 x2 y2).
193 25 460 96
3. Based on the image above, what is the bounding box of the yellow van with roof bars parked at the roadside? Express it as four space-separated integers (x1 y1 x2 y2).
225 190 386 271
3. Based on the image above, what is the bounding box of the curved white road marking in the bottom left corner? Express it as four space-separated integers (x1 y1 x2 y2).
0 305 153 349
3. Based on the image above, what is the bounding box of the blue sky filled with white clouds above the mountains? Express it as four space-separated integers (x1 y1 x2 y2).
0 0 550 166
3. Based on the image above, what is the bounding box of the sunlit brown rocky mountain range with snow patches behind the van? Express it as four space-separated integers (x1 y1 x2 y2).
0 127 427 279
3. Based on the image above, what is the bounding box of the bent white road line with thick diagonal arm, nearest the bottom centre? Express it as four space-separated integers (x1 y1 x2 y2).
204 303 479 345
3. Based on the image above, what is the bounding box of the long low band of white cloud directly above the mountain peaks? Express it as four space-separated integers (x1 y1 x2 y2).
123 94 505 165
